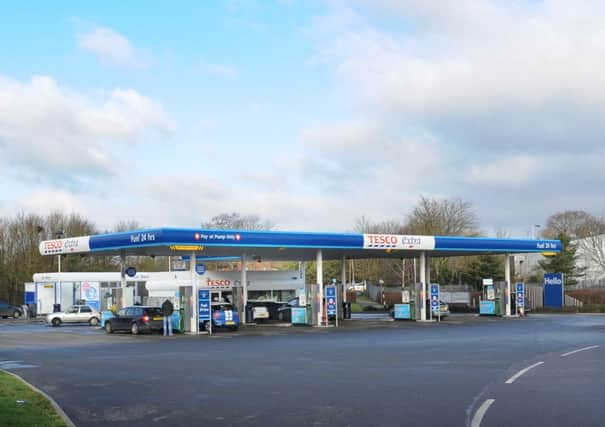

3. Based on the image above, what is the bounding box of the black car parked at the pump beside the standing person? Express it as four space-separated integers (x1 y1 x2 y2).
105 305 164 335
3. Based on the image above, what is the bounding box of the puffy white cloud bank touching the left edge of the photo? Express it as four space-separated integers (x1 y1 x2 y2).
0 76 175 179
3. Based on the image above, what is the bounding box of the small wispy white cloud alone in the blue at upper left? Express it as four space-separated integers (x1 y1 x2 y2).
78 27 151 68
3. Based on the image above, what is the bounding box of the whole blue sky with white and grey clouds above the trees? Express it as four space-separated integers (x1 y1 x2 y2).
0 0 605 237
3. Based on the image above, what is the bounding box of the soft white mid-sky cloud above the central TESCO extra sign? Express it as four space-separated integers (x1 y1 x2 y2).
299 120 441 197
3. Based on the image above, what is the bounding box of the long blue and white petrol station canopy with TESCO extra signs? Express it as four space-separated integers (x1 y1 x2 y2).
40 228 561 261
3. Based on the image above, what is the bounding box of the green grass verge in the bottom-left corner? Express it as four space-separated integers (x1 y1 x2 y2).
0 371 65 427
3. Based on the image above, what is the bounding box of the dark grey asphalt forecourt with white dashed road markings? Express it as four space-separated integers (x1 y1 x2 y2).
0 315 605 427
